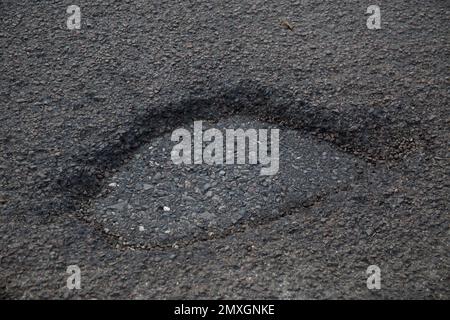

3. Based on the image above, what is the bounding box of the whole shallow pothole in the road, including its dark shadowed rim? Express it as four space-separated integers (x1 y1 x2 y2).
54 84 424 249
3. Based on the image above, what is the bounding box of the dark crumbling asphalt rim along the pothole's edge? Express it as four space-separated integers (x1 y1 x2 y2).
47 82 423 250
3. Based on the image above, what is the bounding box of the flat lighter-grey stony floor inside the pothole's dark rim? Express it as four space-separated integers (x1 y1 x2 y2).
83 116 367 247
